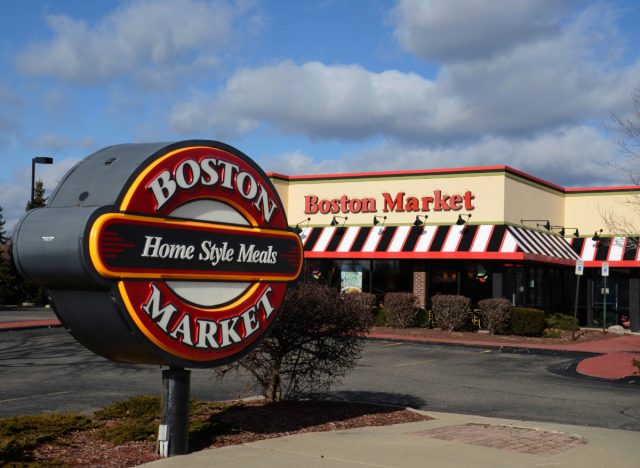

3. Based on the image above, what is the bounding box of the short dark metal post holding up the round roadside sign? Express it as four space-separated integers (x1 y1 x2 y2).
158 367 191 457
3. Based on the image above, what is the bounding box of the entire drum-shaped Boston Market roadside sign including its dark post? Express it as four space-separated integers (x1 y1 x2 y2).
13 140 303 456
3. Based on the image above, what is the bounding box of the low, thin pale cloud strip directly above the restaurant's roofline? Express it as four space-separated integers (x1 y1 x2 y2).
264 126 630 187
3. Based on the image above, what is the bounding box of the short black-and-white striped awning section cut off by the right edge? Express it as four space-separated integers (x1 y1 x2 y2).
569 237 640 268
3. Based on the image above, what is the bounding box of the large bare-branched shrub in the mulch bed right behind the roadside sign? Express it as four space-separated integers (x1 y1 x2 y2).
216 283 374 401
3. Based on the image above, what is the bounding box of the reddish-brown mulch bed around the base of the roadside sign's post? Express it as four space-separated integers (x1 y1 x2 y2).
34 401 432 468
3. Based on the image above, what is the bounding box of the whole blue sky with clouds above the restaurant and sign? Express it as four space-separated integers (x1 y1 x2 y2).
0 0 640 232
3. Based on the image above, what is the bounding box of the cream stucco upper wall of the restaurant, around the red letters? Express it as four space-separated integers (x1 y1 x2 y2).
273 169 640 236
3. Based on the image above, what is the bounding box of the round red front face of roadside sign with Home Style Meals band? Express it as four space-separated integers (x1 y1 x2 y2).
87 141 303 367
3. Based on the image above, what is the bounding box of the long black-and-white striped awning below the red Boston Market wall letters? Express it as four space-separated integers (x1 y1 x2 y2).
300 225 579 265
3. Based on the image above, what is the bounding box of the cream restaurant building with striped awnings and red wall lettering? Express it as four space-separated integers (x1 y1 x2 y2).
270 166 640 331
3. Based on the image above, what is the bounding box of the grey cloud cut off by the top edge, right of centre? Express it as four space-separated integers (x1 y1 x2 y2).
392 0 573 62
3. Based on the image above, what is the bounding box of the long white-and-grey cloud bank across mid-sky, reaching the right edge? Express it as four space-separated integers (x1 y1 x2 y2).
169 46 640 144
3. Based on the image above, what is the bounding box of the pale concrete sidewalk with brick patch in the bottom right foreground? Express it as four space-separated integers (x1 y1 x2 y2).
144 411 639 468
